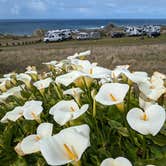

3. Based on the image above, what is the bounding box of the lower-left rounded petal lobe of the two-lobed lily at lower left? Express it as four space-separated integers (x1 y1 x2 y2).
21 134 40 154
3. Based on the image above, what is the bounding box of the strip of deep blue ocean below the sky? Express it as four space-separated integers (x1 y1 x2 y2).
0 19 166 35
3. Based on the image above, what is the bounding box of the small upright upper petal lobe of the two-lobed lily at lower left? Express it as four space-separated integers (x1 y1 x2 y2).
37 123 53 138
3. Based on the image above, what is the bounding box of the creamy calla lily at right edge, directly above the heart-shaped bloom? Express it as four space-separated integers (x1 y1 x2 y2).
139 76 166 101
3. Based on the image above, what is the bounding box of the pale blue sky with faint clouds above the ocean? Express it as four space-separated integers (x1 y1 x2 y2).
0 0 166 19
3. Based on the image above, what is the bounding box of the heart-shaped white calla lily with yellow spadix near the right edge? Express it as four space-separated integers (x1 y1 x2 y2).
127 104 166 136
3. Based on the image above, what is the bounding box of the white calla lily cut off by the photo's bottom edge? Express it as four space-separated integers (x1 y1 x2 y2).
100 157 132 166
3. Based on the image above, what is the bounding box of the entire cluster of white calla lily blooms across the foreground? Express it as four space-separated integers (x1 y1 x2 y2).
0 51 166 166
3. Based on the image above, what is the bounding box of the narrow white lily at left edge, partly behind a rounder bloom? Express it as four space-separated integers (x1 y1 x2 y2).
1 107 23 123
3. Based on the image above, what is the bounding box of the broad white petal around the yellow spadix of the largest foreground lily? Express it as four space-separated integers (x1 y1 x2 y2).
40 124 90 165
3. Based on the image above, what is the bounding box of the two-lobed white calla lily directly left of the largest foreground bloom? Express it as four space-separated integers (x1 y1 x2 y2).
21 123 53 154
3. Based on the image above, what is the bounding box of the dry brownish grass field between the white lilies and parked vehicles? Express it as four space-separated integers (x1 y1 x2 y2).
0 34 166 74
